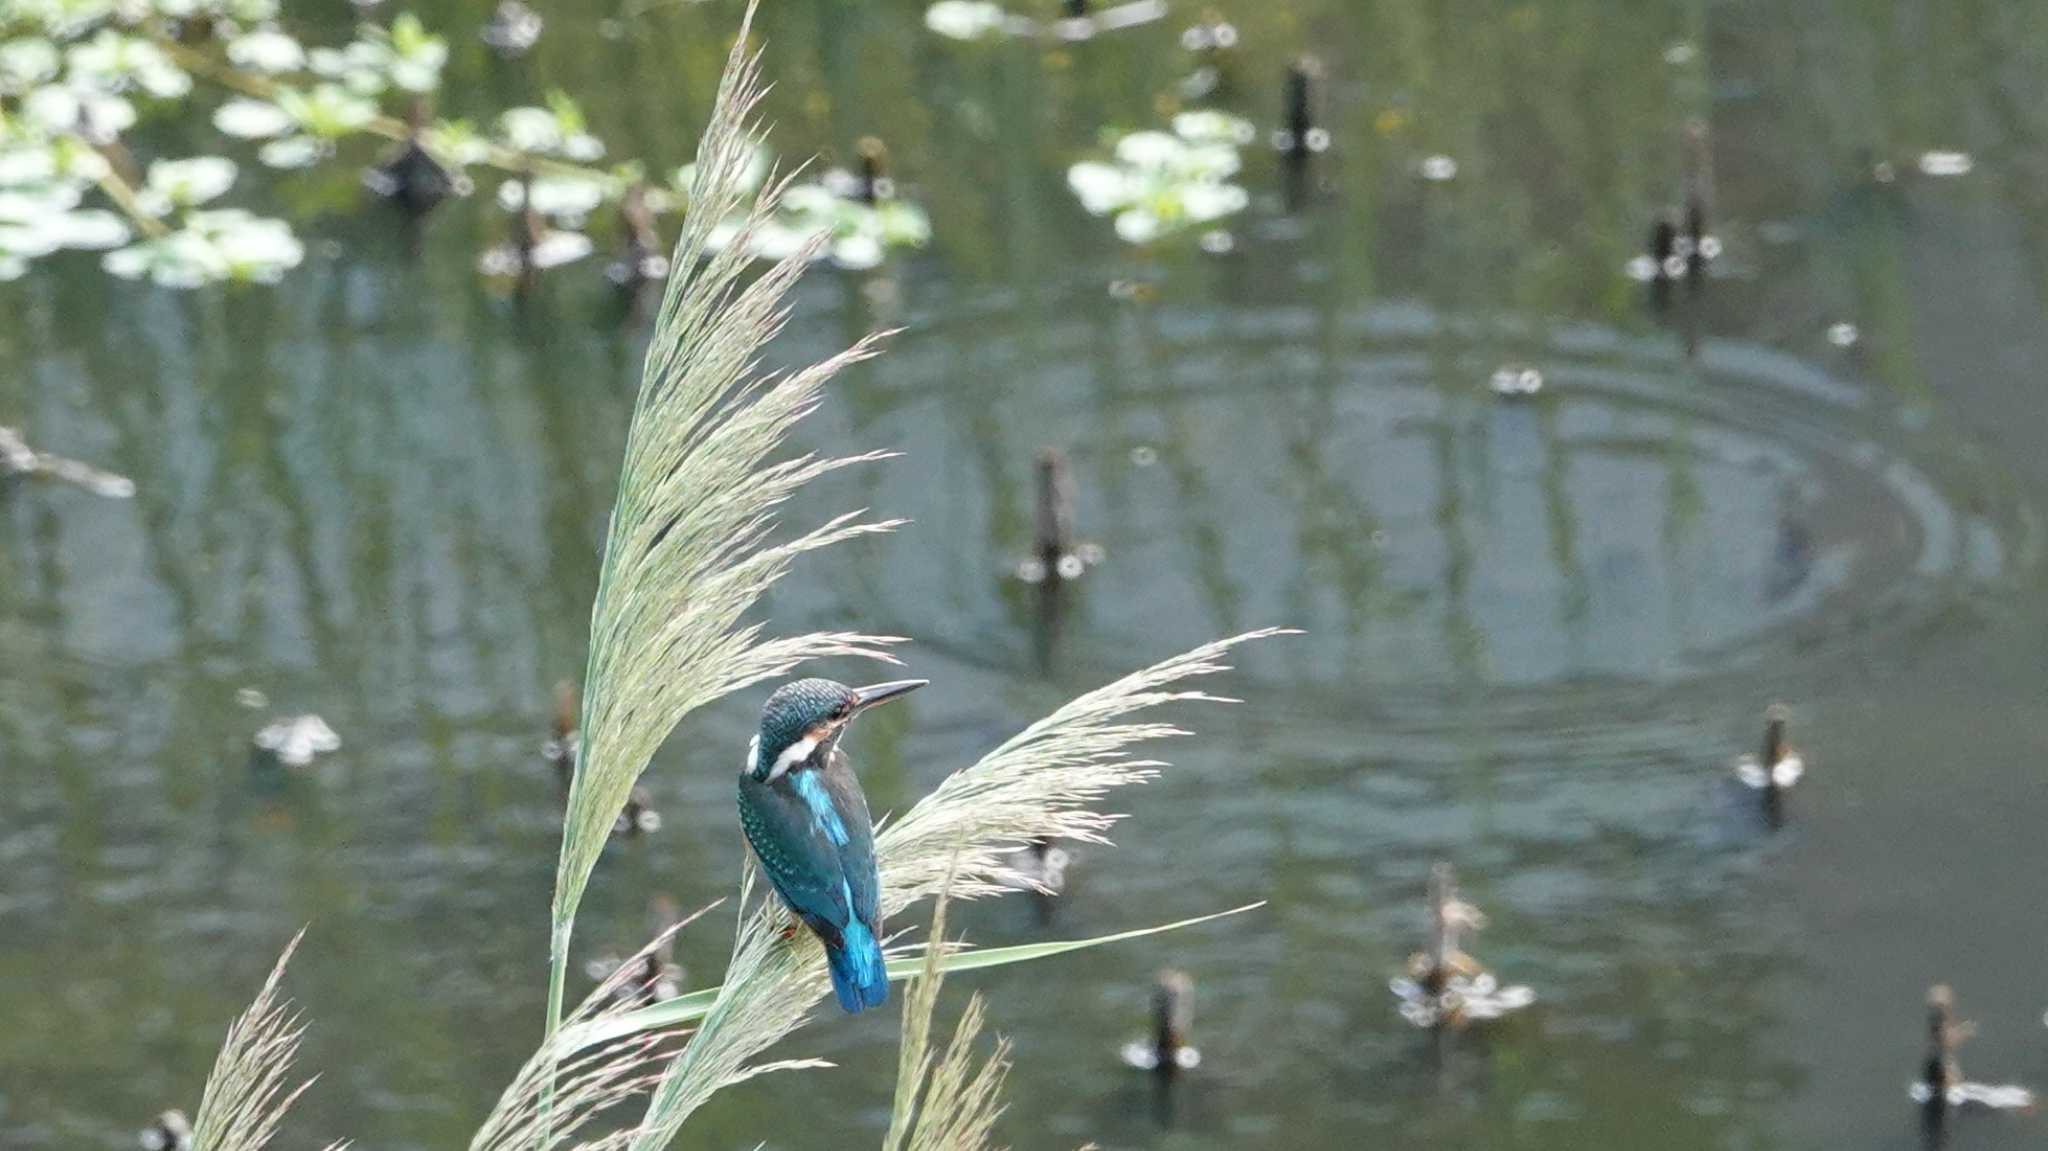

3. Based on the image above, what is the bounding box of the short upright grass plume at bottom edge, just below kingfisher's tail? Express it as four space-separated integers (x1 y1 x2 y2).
883 866 1010 1151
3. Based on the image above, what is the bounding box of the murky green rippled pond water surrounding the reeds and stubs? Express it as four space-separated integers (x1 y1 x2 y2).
0 0 2048 1151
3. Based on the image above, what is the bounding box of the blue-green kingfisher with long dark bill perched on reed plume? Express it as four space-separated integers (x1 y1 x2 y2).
739 680 928 1014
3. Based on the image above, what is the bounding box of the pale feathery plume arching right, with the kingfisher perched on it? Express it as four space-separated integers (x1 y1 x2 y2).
631 629 1280 1151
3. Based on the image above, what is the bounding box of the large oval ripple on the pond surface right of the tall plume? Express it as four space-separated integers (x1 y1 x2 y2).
811 290 2034 729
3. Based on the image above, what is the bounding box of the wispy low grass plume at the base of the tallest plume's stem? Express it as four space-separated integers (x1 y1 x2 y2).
469 899 725 1151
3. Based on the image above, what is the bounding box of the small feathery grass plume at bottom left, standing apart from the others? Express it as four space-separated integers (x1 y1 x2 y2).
193 930 342 1151
